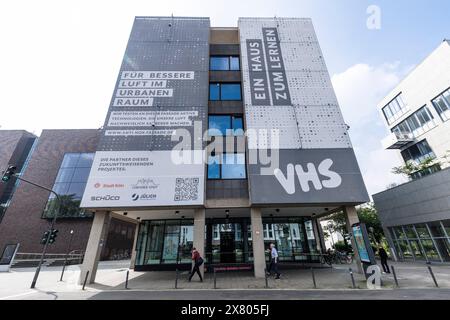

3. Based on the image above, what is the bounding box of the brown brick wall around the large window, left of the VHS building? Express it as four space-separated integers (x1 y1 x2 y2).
0 130 99 253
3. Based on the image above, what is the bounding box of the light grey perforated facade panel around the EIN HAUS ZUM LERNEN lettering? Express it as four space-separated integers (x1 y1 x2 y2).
239 18 351 149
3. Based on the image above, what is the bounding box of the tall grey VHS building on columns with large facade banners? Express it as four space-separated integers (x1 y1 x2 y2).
80 17 368 282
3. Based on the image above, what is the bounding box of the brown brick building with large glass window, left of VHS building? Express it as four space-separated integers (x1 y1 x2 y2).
0 129 135 259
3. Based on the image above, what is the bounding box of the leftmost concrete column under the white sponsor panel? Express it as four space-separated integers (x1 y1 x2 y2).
78 211 110 284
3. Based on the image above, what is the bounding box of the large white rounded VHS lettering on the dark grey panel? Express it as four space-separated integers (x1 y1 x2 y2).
274 159 342 194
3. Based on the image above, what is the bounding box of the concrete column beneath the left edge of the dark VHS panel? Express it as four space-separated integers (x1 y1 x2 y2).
250 208 266 278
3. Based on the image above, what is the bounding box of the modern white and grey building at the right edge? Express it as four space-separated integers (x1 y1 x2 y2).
373 40 450 261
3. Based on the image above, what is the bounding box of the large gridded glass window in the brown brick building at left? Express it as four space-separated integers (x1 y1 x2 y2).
43 153 94 218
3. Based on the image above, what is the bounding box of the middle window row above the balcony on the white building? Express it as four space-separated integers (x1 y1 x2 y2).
392 106 435 137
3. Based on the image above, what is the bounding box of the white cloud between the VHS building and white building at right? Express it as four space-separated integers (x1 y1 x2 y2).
332 62 411 195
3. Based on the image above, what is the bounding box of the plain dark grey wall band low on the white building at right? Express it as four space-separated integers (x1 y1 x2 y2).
372 168 450 227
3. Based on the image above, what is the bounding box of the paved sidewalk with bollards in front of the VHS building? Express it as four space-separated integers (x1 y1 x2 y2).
0 261 450 300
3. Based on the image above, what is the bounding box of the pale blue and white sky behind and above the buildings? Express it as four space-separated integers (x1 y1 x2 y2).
0 0 450 198
